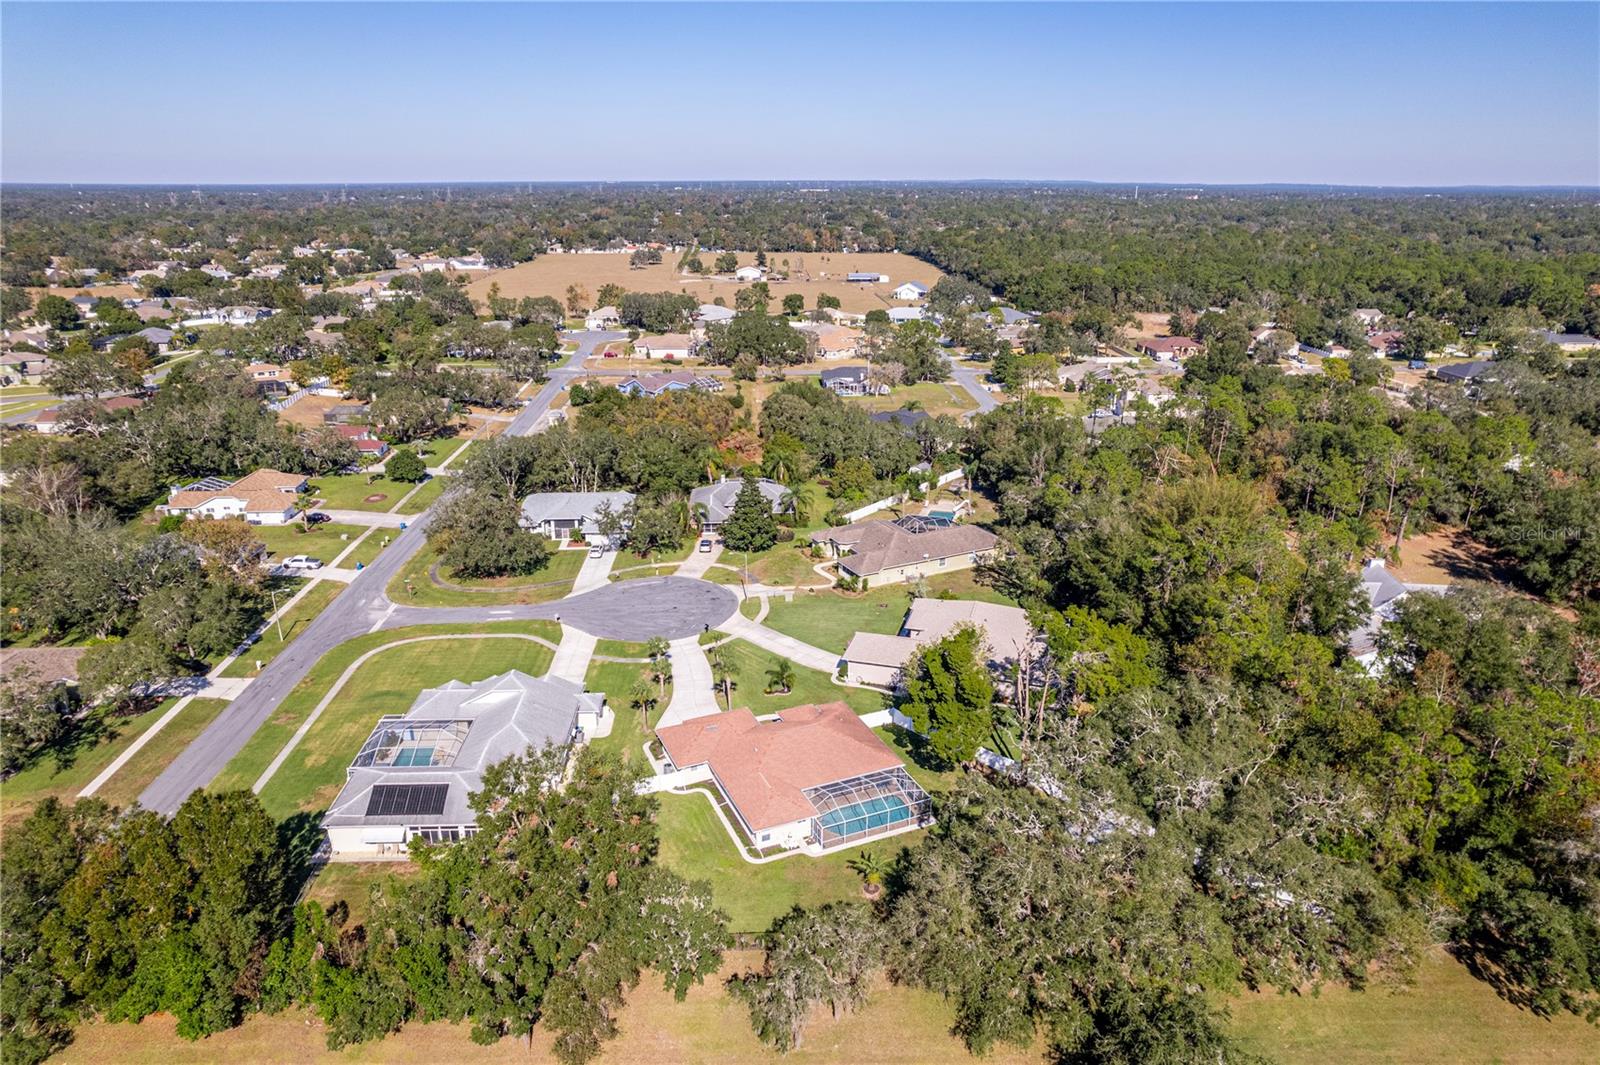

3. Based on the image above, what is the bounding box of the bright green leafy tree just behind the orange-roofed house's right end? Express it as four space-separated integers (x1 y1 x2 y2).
899 625 995 766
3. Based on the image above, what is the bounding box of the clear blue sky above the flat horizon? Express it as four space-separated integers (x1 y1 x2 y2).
0 3 1600 185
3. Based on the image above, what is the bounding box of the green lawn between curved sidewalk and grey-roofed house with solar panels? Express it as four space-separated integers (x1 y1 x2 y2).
261 633 554 817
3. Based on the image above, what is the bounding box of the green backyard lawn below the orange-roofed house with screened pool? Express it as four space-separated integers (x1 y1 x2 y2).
658 793 922 932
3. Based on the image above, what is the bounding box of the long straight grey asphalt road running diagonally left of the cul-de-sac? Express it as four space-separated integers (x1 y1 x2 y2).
139 333 627 814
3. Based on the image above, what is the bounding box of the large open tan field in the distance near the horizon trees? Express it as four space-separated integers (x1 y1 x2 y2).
467 251 944 313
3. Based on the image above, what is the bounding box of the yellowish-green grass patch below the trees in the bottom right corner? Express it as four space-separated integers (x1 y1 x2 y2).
1229 950 1600 1065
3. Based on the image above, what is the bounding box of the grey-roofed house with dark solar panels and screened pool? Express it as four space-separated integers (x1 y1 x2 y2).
322 670 608 862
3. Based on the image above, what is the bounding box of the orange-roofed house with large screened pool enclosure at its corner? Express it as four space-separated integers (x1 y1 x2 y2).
656 702 933 854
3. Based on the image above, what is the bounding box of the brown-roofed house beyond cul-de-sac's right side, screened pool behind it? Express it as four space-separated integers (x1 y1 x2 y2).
811 515 998 585
